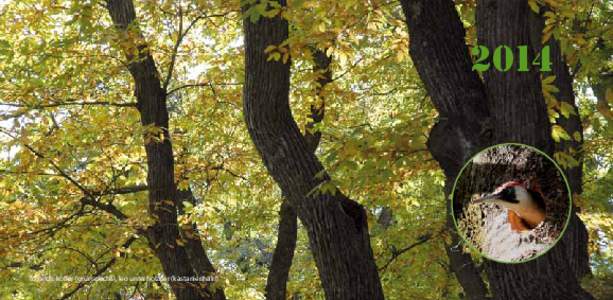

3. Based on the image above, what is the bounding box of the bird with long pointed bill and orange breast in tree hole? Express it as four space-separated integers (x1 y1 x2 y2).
472 180 546 232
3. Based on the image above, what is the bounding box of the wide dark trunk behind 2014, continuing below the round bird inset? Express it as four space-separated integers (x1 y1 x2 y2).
477 0 591 299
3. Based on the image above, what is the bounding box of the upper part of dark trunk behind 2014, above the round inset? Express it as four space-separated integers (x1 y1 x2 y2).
476 0 553 149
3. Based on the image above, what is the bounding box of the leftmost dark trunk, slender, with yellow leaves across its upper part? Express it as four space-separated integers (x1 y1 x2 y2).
107 0 225 300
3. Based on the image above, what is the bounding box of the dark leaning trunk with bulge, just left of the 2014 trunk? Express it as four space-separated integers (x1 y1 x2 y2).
401 1 492 299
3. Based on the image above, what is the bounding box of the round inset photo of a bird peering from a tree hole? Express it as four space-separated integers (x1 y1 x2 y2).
451 144 571 263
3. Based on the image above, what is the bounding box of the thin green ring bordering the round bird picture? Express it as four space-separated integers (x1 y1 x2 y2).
449 143 573 265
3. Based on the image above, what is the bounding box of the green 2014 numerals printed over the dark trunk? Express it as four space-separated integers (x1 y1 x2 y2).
470 45 551 72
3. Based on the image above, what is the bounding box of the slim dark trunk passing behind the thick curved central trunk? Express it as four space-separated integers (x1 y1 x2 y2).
266 50 332 300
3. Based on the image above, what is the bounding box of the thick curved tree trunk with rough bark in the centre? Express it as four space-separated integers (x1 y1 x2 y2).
243 1 383 300
